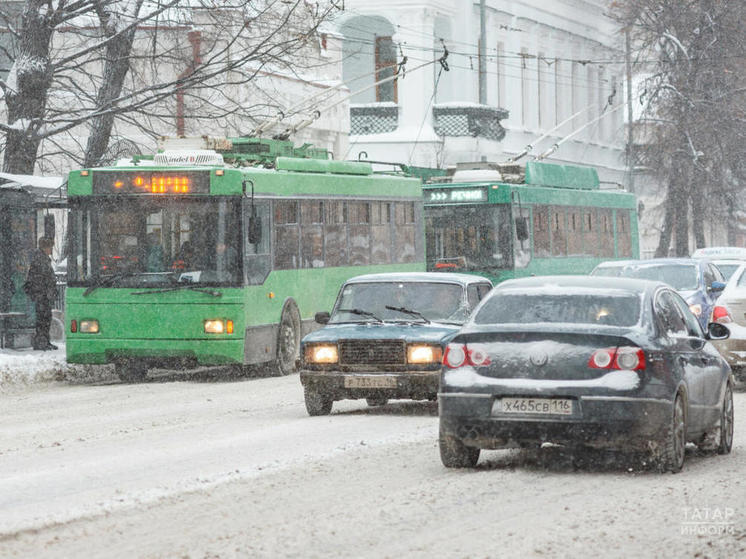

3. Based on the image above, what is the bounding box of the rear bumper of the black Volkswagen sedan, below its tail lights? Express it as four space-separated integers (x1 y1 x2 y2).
438 393 673 449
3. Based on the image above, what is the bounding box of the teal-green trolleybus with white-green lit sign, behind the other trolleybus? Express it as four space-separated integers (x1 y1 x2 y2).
423 161 640 283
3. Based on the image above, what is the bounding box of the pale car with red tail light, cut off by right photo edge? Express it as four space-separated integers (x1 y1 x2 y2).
712 262 746 381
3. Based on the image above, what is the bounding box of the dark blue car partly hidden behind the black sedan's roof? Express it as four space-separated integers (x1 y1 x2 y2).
592 258 725 330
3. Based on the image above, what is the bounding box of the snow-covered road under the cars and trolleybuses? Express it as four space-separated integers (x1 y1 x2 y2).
0 375 746 557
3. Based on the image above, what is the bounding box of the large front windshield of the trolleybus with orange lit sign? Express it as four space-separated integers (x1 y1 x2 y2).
68 197 241 287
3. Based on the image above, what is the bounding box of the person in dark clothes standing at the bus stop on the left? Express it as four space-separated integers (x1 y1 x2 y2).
24 237 57 351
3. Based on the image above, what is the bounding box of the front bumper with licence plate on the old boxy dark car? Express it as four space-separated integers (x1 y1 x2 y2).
300 370 440 400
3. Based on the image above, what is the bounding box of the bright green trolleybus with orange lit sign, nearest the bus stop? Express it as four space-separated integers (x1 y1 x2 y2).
66 138 425 381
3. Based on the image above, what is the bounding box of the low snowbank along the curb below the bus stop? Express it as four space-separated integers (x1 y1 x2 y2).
0 342 68 393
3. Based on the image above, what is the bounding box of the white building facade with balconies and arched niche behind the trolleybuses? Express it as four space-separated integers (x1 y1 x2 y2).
338 0 626 188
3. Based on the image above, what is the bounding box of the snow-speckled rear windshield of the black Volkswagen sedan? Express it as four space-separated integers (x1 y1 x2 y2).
474 291 640 326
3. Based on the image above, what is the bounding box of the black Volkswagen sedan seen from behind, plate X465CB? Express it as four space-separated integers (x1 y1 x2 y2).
438 276 733 472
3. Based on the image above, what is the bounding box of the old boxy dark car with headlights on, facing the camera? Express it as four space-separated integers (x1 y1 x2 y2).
298 272 492 415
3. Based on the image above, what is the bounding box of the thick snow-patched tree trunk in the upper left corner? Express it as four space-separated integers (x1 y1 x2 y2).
3 0 55 175
